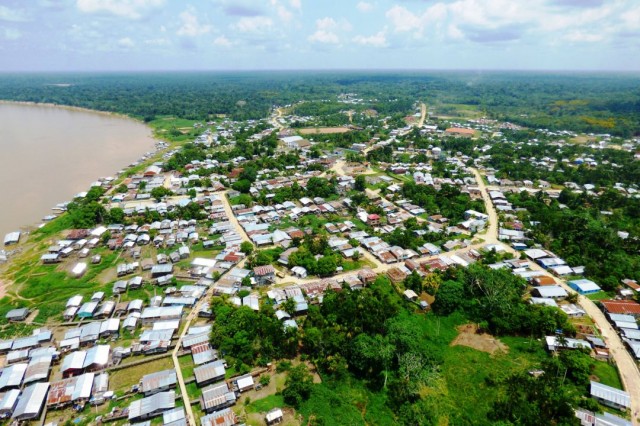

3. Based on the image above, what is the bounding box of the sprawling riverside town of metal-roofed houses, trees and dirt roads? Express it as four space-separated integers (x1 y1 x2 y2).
0 93 640 426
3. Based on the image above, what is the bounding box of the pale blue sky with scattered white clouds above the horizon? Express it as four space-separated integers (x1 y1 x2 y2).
0 0 640 72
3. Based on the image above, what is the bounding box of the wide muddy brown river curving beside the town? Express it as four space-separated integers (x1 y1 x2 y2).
0 103 154 238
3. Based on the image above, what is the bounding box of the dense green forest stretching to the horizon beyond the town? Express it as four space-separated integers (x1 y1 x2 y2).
0 71 640 137
